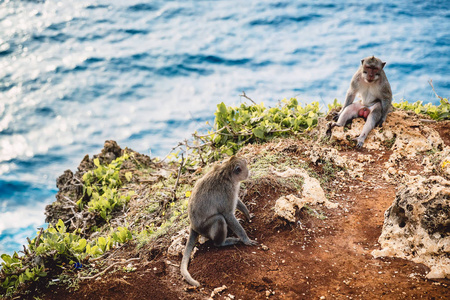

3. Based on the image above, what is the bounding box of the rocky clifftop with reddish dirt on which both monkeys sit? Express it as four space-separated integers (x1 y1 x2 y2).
3 110 450 299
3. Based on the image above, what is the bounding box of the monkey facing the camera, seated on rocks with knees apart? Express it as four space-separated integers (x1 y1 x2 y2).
327 56 392 147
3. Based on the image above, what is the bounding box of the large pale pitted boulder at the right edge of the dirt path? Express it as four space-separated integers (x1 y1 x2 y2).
372 176 450 278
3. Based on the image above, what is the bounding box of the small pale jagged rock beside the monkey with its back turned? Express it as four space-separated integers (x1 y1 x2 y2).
274 168 338 222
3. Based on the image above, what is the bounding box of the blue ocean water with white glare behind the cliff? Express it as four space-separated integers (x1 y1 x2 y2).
0 0 450 253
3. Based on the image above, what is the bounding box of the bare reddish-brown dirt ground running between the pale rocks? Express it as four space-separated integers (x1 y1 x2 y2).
27 122 450 300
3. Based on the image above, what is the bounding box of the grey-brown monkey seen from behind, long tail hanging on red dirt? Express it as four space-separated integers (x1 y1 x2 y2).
180 156 257 286
